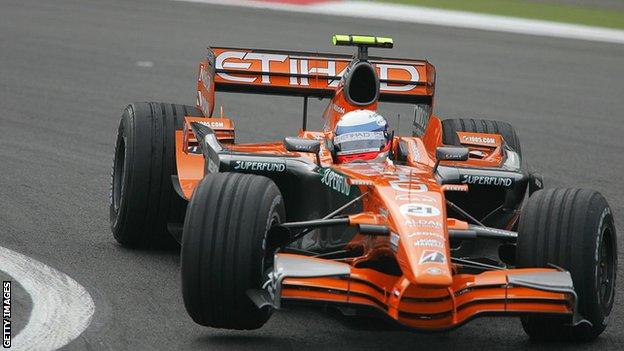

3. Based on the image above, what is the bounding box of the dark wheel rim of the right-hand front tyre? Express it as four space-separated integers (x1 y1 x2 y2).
598 228 616 314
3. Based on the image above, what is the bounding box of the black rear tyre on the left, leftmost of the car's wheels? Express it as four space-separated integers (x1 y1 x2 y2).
110 102 201 247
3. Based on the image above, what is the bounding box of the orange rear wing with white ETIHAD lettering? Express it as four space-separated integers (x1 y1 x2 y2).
197 47 435 116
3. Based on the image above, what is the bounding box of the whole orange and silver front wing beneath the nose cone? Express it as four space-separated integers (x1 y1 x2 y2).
255 254 586 331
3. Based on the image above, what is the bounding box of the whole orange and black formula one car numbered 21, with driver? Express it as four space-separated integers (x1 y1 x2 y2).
110 35 617 340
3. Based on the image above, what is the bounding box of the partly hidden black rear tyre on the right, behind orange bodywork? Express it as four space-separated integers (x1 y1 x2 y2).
442 118 522 156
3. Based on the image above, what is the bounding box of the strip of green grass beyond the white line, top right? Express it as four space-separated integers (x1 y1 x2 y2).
372 0 624 29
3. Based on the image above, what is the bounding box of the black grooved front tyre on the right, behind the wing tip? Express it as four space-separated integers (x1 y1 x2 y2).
516 189 617 341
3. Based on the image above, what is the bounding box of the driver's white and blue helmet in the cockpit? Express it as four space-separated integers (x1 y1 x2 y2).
333 110 392 163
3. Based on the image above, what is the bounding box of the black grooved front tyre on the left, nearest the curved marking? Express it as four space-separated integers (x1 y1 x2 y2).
181 173 285 329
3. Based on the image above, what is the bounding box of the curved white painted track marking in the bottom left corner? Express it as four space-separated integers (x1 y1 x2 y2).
0 246 95 350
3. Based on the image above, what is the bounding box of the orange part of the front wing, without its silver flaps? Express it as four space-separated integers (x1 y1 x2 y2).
281 268 573 330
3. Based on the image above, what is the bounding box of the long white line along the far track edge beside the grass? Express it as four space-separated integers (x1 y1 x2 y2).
173 0 624 44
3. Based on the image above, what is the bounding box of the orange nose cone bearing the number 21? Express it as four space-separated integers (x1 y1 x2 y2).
334 163 453 288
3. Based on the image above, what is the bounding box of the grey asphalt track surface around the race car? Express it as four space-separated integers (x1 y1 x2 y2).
0 0 624 350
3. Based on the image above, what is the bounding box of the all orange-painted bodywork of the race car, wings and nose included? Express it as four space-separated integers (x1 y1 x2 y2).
175 48 574 330
